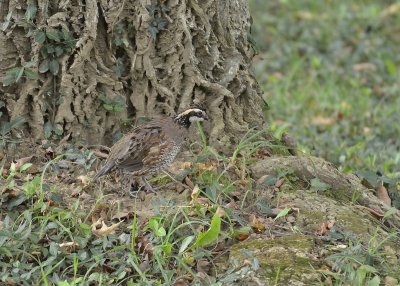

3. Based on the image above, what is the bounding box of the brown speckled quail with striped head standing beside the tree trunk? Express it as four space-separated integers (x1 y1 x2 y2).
94 107 208 195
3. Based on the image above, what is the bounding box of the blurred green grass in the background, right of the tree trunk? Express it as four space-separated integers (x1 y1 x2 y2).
250 0 400 176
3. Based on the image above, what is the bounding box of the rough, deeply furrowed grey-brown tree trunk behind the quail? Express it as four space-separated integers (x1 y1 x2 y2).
0 0 263 151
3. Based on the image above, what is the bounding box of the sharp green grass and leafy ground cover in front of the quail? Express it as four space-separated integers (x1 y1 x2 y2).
0 128 268 286
